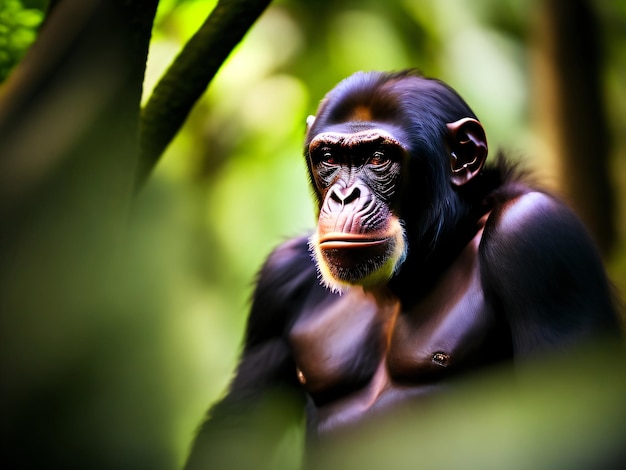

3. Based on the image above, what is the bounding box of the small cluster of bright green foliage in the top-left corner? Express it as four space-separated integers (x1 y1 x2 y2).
0 0 43 82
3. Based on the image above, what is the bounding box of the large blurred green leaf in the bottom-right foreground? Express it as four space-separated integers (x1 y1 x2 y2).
311 344 626 470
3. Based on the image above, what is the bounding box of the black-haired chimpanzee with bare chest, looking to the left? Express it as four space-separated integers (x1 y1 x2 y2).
182 70 620 468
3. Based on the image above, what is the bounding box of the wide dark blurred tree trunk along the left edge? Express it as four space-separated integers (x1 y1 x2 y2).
0 0 158 469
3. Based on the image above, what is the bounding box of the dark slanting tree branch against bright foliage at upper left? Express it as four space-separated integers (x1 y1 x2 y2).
136 0 271 188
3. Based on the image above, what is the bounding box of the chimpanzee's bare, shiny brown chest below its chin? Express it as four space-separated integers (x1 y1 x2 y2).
289 239 496 430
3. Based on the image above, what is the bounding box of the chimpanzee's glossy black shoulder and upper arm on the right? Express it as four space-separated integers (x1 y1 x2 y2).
480 192 620 357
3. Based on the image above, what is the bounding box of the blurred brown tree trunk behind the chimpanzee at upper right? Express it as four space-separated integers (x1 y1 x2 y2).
535 0 616 255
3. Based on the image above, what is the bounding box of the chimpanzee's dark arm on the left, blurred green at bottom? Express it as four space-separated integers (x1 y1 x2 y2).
185 239 318 470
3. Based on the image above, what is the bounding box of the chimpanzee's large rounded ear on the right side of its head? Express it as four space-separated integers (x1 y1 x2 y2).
446 118 488 186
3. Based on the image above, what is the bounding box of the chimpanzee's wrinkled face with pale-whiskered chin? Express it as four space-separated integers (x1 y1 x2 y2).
309 129 406 291
